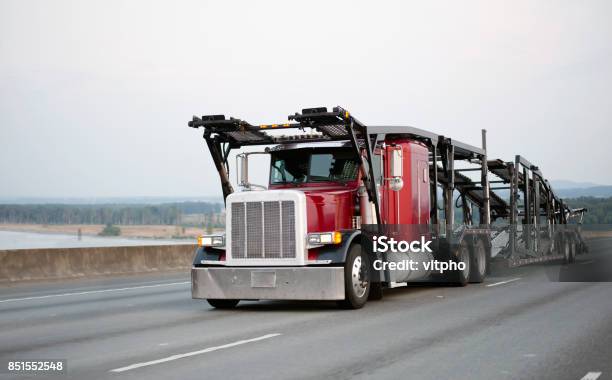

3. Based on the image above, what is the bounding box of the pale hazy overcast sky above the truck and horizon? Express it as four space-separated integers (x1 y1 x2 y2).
0 0 612 197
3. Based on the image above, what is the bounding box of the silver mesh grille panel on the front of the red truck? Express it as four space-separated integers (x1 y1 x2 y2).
230 201 296 259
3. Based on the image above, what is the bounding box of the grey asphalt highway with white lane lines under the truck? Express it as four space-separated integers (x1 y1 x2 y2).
0 239 612 380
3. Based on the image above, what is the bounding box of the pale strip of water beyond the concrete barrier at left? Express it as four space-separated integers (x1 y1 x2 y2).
0 231 196 250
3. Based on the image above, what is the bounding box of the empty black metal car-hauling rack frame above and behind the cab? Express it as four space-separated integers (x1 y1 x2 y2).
188 107 586 277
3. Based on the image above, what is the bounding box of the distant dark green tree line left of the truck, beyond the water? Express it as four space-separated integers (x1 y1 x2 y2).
0 202 222 225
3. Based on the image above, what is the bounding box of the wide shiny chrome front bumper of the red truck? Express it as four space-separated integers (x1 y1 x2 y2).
191 267 344 300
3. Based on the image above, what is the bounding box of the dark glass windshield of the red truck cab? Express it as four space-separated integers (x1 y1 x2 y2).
270 148 359 185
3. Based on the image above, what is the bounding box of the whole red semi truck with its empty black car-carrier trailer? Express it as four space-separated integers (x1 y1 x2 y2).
189 107 586 308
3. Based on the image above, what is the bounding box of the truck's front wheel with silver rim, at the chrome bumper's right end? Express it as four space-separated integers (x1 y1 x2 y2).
338 244 371 309
